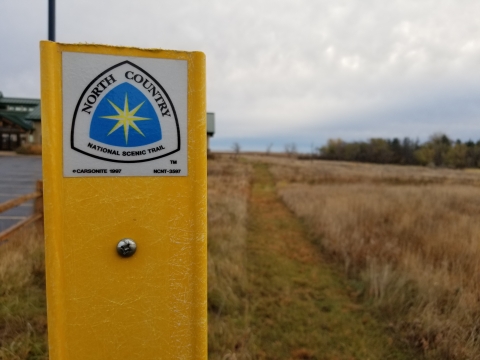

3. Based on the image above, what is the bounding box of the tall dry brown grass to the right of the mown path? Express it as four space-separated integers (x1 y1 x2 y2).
258 159 480 359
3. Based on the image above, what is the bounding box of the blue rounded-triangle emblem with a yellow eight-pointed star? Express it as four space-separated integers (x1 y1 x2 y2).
89 82 162 147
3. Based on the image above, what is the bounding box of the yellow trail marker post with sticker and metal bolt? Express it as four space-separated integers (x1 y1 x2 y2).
41 42 207 360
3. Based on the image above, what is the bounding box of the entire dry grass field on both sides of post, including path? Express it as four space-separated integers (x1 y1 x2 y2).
0 155 480 360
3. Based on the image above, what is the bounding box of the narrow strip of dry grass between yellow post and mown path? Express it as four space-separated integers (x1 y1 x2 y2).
208 156 252 360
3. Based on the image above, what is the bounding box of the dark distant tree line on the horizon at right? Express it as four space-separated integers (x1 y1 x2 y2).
318 133 480 169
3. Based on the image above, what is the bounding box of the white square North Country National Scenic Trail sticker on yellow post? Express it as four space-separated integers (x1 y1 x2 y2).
62 52 188 177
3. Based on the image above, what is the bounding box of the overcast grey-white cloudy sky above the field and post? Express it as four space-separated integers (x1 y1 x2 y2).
0 0 480 151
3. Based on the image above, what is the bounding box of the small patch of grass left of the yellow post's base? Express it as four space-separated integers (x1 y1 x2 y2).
0 224 48 360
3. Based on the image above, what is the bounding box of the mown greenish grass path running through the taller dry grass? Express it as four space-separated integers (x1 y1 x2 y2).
247 163 413 359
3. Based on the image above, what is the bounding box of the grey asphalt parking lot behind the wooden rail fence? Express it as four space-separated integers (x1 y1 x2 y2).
0 155 42 232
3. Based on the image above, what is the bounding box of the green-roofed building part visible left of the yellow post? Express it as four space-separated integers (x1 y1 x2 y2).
0 92 41 150
